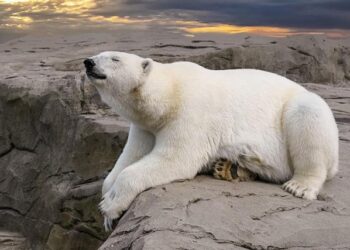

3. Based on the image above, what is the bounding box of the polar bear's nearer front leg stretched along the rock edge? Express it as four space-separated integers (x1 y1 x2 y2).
100 133 207 229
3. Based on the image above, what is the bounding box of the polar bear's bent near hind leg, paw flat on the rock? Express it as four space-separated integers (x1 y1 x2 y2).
282 92 338 200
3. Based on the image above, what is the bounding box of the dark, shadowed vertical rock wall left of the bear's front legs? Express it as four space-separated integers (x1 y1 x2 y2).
0 71 128 249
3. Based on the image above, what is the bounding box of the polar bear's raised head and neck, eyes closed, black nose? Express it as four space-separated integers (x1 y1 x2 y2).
84 51 176 129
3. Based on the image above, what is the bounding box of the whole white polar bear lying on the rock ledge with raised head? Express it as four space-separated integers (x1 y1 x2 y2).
84 52 338 229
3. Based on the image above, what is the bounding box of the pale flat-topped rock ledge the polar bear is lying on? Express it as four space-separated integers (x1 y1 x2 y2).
100 84 350 250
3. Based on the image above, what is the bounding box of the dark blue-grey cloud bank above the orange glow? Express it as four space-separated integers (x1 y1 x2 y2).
92 0 350 29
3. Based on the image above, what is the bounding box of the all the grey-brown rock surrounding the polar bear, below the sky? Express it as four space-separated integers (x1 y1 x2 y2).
0 32 350 250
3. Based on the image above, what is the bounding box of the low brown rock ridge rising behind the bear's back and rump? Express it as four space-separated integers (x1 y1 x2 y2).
188 37 350 84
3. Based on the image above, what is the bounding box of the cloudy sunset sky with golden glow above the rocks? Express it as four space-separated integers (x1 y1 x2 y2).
0 0 350 38
